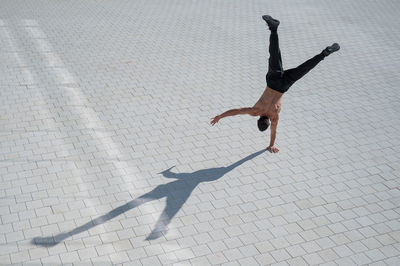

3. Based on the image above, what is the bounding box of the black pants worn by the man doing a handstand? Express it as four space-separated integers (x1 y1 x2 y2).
266 30 325 93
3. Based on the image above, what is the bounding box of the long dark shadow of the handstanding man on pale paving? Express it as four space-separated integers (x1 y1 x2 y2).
31 149 265 247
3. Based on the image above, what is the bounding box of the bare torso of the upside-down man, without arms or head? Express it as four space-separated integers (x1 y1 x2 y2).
253 86 283 120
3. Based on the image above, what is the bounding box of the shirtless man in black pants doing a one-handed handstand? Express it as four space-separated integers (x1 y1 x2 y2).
211 15 340 153
